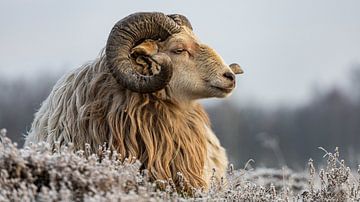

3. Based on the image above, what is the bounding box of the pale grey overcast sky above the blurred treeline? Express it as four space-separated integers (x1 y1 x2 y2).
0 0 360 104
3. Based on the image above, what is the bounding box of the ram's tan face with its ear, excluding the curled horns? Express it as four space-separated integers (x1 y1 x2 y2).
133 27 242 99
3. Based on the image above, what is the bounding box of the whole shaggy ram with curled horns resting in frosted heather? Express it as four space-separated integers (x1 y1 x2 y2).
25 12 242 192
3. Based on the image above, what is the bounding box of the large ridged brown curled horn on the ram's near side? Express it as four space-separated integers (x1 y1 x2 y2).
105 12 181 93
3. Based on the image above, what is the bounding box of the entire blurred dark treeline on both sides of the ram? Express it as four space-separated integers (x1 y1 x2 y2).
0 65 360 169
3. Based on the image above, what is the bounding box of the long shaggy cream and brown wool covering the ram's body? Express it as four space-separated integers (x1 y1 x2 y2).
26 51 219 187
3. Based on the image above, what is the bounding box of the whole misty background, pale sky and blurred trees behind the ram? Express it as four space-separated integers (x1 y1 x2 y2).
0 0 360 169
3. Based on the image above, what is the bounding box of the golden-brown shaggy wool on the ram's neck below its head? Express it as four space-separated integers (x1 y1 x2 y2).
108 92 209 190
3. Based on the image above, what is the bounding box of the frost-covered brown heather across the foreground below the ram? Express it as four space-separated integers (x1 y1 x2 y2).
0 130 360 201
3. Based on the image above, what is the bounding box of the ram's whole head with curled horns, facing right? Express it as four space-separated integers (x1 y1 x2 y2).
106 13 242 99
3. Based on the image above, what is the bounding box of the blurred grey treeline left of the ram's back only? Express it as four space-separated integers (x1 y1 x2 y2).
0 72 60 146
